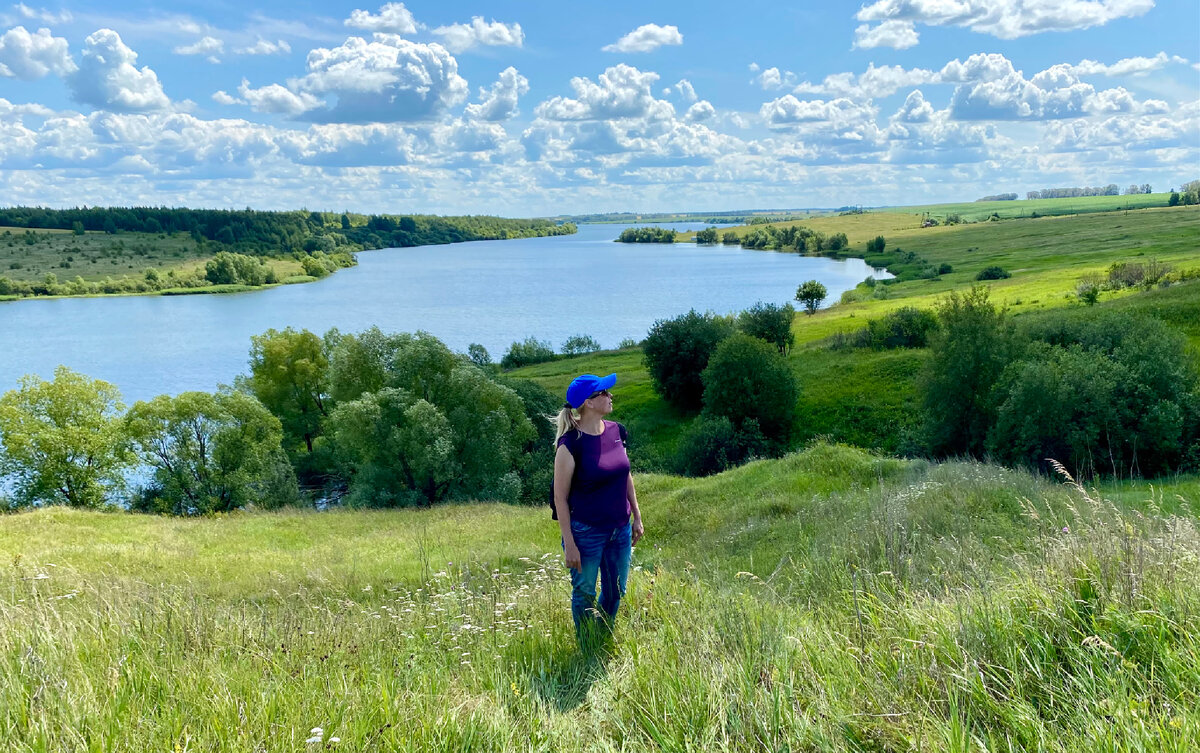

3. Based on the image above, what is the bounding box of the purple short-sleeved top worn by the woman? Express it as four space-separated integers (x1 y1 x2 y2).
558 421 630 528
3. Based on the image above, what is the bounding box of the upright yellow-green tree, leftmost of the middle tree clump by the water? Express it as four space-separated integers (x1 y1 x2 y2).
244 327 330 453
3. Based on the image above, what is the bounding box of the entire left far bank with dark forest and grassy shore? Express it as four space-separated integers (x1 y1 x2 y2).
0 206 576 300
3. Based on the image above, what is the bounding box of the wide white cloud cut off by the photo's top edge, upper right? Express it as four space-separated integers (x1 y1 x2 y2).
854 0 1154 40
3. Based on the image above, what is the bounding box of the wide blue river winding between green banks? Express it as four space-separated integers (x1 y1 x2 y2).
0 224 888 403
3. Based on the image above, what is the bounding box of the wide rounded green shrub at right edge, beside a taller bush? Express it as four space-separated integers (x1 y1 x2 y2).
989 309 1198 476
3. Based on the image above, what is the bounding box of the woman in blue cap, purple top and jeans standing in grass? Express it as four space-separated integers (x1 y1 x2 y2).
554 374 643 641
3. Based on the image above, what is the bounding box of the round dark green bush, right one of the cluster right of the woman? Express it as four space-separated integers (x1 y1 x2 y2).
702 333 799 446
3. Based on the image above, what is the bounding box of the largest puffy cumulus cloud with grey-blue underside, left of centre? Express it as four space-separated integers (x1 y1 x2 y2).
288 34 468 122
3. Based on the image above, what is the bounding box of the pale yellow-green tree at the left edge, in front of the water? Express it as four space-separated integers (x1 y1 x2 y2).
0 366 132 507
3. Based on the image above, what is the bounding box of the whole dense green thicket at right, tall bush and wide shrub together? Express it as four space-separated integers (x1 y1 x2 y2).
919 289 1200 477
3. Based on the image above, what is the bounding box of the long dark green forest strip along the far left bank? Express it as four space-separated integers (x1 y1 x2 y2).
0 206 576 255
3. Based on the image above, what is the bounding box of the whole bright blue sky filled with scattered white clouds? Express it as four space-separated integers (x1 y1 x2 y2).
0 0 1200 217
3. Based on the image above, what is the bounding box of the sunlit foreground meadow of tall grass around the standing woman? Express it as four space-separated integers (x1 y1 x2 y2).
0 445 1200 752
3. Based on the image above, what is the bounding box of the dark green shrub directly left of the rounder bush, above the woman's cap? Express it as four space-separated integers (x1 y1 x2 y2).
642 309 733 410
